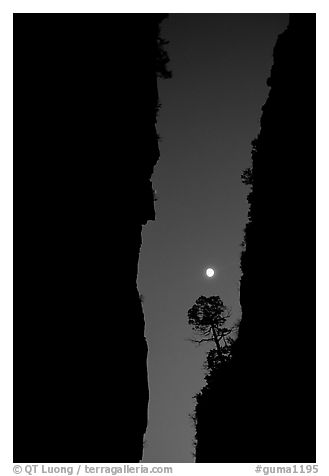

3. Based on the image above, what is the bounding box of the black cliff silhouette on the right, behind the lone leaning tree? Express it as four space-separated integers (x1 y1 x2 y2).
194 14 316 463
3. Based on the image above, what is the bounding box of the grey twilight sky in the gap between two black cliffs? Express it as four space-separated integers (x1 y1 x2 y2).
138 14 288 463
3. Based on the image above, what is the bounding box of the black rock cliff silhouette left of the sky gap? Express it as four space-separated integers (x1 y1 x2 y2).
14 14 170 463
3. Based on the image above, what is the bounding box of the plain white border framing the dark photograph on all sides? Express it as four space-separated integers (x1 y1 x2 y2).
0 0 329 476
